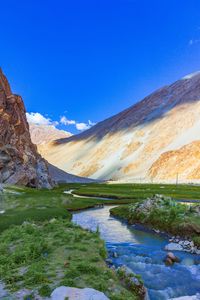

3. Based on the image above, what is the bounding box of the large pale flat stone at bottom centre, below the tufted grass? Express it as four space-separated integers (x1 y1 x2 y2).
51 286 109 300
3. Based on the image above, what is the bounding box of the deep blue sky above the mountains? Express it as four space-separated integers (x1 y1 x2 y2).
0 0 200 133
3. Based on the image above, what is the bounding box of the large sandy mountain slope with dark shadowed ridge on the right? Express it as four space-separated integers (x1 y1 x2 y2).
39 72 200 182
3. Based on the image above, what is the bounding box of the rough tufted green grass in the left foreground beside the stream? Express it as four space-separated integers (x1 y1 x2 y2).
0 219 137 300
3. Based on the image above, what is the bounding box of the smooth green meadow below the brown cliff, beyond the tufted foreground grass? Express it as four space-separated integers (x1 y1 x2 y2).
0 184 138 231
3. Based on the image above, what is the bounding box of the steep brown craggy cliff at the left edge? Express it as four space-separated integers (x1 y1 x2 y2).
0 70 53 188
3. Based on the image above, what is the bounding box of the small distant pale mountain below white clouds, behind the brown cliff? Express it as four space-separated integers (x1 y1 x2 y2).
29 123 72 145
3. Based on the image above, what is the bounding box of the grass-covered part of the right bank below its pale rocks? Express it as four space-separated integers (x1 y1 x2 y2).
111 200 200 246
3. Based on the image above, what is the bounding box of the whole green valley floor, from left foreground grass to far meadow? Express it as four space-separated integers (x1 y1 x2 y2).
0 184 200 300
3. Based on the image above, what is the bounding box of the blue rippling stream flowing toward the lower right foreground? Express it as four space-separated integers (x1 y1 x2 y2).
73 206 200 300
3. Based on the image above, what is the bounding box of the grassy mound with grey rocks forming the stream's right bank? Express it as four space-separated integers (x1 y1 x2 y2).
110 195 200 254
